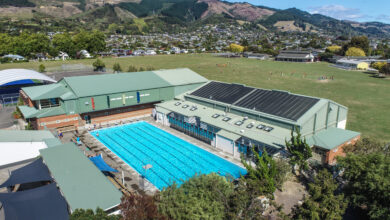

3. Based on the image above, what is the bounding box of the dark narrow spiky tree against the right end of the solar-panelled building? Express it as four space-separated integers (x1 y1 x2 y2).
286 127 312 171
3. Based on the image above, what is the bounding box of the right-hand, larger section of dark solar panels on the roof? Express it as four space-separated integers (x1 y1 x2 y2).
234 89 319 121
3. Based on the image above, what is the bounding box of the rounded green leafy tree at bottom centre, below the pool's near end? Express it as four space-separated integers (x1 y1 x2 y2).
158 173 234 219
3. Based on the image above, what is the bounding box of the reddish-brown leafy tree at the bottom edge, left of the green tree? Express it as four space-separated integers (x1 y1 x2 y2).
119 193 165 220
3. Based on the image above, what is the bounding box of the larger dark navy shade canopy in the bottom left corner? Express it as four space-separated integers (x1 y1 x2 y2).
0 183 69 220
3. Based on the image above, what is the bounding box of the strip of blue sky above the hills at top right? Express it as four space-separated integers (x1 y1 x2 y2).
228 0 390 24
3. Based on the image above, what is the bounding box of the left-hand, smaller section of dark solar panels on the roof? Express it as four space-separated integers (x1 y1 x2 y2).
191 82 254 104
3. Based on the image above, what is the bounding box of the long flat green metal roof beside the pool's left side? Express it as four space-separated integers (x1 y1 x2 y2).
40 143 122 211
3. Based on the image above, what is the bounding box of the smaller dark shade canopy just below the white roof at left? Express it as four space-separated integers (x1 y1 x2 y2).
0 158 52 188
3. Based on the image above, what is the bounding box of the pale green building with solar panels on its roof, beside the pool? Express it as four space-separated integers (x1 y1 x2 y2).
156 81 360 164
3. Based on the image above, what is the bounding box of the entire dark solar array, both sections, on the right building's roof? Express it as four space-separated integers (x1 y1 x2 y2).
191 82 319 121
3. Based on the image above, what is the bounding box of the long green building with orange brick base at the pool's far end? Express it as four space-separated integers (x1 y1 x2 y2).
19 69 207 131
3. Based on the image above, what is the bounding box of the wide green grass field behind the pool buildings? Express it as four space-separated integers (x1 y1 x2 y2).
0 55 390 141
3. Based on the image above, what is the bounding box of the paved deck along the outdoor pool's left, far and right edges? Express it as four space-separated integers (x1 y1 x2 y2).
79 116 243 195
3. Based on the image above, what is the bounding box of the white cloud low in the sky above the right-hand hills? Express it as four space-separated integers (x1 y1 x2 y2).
309 5 371 21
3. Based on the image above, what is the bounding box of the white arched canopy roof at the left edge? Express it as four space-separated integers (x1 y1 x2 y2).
0 69 56 86
